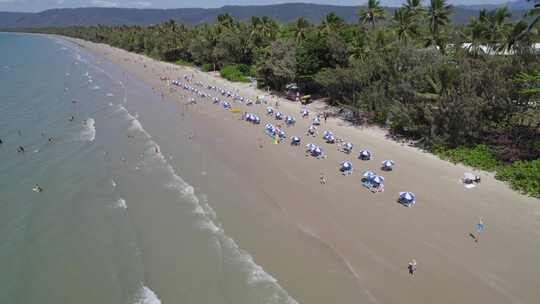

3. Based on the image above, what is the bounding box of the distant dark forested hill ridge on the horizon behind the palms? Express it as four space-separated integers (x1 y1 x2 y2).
0 3 525 28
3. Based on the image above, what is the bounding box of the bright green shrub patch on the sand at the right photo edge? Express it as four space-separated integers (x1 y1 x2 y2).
495 159 540 198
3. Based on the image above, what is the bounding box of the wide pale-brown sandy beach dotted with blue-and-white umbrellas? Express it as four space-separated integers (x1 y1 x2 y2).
69 39 540 304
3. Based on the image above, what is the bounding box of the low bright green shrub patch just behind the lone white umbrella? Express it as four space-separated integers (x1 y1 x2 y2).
432 145 500 171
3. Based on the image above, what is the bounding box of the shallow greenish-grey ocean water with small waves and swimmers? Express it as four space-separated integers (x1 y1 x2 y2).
0 33 295 304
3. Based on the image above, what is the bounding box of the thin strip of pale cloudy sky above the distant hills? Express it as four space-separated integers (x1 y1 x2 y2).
0 0 515 12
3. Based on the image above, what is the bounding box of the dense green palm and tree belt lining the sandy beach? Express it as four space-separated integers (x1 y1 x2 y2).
16 0 540 196
